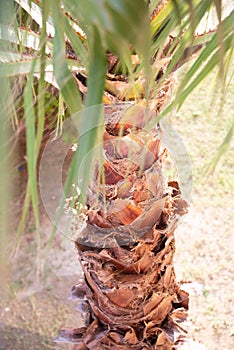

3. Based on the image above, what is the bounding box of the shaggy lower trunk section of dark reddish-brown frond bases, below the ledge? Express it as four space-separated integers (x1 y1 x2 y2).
57 193 188 350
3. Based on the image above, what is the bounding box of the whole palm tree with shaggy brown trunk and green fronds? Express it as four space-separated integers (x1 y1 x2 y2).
2 0 234 350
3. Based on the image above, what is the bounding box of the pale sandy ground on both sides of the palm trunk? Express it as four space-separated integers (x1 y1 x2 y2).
0 65 234 350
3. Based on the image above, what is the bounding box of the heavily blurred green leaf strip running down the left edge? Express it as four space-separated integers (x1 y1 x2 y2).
0 0 15 282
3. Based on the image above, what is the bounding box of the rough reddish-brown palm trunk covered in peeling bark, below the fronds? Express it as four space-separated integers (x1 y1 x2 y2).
57 102 188 350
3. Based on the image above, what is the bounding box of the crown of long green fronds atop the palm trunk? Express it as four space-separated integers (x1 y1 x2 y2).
0 0 234 245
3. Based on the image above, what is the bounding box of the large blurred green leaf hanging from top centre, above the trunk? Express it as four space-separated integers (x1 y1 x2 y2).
64 0 151 73
